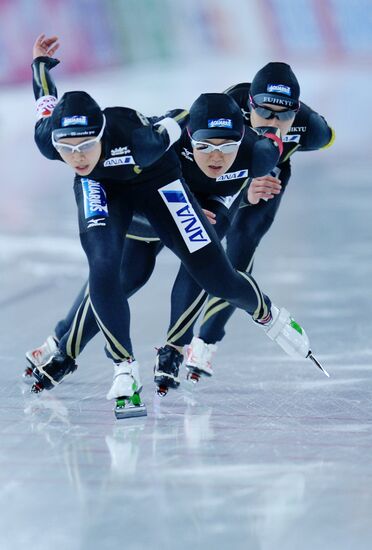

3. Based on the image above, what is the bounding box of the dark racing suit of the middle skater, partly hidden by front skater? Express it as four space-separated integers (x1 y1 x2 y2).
56 119 282 357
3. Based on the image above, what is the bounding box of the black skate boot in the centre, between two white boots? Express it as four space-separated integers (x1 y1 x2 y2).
154 344 183 397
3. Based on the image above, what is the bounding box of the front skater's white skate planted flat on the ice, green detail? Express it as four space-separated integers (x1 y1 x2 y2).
106 361 147 419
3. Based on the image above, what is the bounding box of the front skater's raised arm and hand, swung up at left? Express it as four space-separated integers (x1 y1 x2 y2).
31 34 60 159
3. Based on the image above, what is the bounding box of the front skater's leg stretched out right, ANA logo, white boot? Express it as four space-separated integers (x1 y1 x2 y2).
143 177 320 384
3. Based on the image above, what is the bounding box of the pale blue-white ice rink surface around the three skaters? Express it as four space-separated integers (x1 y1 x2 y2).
0 60 372 550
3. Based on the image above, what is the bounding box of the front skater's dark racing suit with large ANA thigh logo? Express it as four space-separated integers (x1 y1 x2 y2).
33 57 277 362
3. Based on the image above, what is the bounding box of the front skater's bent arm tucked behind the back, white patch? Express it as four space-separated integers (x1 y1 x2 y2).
132 109 188 167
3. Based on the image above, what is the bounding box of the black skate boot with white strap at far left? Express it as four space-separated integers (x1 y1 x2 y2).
31 351 77 393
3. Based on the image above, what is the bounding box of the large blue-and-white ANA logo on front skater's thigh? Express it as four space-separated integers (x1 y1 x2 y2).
158 180 211 253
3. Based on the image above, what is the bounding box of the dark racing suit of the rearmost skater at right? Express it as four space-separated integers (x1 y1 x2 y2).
199 84 334 343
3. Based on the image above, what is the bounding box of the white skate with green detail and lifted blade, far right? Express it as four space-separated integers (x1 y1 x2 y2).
259 304 329 378
